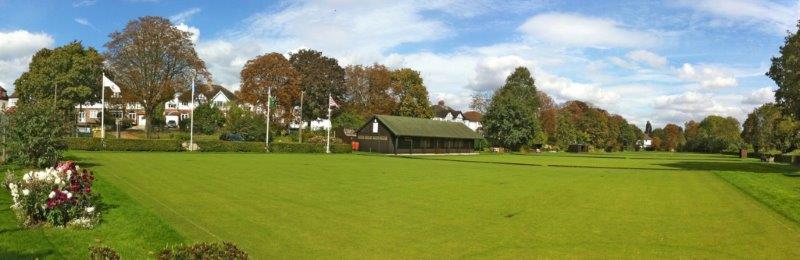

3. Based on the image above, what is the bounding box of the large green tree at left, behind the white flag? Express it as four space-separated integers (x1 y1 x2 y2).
14 41 103 125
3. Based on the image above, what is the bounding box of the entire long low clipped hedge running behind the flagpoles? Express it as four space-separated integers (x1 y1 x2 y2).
66 138 351 153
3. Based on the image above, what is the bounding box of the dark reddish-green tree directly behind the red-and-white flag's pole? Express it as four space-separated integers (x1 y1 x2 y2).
289 49 346 119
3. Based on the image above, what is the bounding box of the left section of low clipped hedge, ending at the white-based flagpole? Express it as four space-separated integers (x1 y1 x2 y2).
66 138 183 152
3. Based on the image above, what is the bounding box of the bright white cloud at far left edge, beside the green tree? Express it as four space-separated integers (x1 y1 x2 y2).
0 30 54 91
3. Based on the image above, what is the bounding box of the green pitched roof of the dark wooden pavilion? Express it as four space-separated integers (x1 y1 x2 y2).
375 115 483 139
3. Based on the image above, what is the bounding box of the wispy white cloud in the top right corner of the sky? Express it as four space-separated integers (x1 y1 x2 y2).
679 0 800 35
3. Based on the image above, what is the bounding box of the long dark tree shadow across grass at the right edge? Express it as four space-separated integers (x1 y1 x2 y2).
659 161 800 177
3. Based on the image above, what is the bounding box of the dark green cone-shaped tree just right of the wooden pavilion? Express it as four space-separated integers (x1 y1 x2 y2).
483 67 541 150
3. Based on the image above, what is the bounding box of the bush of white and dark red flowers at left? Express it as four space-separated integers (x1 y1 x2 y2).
7 161 99 228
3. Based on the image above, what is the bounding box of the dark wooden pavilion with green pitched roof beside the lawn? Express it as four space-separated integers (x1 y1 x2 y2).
356 115 482 154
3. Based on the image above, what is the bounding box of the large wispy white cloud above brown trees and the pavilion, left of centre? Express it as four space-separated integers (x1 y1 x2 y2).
197 1 451 89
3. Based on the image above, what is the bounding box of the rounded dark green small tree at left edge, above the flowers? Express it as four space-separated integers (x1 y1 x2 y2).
3 99 66 167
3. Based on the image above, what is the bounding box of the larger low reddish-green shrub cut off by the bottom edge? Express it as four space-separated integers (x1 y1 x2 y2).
156 242 248 260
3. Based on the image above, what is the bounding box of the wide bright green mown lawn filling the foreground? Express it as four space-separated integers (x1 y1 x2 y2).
0 152 800 259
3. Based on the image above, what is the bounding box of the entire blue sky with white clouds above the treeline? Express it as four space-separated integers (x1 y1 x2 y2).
0 0 800 127
